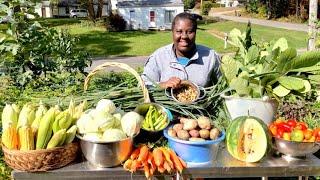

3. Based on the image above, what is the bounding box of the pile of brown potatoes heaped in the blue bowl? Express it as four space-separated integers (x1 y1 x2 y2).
168 116 220 141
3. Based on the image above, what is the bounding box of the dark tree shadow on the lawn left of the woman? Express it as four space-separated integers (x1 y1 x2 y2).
77 31 156 56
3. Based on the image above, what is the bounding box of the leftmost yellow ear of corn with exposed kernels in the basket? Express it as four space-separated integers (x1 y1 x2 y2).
2 124 20 149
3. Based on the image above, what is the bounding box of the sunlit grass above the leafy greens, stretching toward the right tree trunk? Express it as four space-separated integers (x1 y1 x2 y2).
200 21 308 48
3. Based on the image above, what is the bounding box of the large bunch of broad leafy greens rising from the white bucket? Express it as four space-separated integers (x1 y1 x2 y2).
221 24 320 98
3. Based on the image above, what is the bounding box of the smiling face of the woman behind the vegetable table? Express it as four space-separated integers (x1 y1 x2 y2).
172 19 196 54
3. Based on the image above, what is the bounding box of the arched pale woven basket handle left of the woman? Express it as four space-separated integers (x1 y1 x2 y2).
84 62 151 103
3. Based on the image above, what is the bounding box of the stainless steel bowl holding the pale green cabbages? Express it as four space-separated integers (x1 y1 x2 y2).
77 135 134 167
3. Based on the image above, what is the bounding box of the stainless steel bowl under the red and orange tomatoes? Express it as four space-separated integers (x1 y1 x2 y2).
274 137 320 157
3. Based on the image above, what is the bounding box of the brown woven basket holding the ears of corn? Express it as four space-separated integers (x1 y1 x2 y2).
2 142 79 172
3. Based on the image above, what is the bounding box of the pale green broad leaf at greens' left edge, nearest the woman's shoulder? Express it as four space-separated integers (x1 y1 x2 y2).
221 56 239 83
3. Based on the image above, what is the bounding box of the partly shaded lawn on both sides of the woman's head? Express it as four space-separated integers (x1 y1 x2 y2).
60 25 231 56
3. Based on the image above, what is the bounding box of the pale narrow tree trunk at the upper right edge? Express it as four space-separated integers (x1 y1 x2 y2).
308 0 318 51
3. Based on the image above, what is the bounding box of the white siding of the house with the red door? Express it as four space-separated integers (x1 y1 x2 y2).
118 6 184 29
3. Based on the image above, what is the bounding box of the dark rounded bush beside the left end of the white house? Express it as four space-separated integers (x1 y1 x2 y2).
106 13 127 32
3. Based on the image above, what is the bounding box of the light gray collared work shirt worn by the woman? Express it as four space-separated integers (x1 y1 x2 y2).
142 44 221 87
